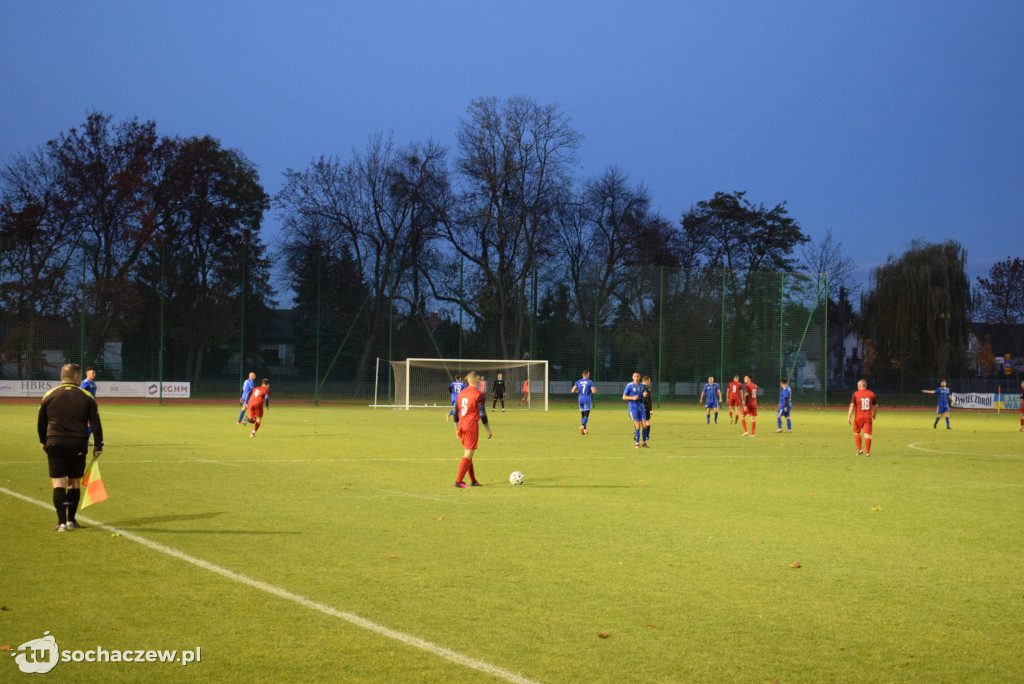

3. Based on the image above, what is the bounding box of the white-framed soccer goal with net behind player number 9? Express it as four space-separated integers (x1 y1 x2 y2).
373 358 548 411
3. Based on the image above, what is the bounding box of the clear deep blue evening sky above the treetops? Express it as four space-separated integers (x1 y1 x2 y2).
0 0 1024 296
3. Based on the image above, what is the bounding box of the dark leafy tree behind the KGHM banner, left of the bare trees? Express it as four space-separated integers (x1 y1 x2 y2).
143 136 273 382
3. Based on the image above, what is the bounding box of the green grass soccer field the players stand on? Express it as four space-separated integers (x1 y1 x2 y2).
0 402 1024 682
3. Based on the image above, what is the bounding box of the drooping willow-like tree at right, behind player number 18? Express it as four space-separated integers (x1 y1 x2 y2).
860 241 971 383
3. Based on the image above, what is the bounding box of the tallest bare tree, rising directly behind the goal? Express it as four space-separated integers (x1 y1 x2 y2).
445 97 583 358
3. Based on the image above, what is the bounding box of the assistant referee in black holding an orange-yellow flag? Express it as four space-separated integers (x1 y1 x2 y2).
37 364 103 532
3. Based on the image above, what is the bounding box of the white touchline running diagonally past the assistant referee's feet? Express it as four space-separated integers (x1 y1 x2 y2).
0 487 540 684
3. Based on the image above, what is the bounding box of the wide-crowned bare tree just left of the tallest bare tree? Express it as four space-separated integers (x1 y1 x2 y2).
275 133 450 387
